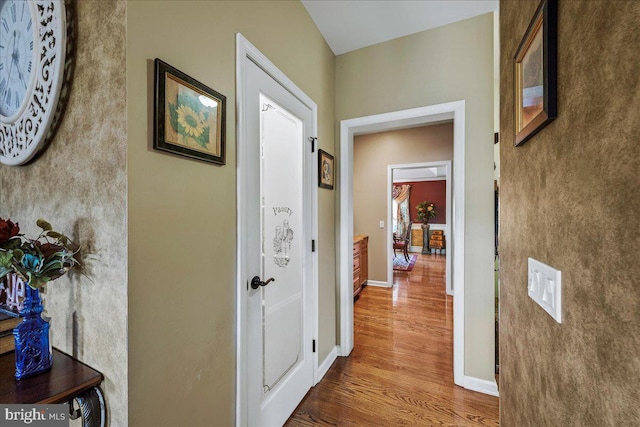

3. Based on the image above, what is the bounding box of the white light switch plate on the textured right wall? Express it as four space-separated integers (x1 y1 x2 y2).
528 258 562 323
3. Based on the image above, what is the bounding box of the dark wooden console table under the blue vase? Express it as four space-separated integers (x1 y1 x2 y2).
0 348 107 427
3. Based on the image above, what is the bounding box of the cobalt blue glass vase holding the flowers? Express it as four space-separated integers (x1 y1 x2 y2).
13 284 52 380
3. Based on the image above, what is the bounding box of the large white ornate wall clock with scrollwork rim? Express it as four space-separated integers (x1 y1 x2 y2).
0 0 74 165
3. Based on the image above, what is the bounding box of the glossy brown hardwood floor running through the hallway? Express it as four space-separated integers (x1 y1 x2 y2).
285 254 498 427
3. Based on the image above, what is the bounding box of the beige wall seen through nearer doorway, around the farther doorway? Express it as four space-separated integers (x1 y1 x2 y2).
353 123 453 283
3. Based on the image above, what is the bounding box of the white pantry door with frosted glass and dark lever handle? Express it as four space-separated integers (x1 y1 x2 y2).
239 54 314 426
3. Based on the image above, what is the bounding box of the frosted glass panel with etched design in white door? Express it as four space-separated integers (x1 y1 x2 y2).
260 95 304 393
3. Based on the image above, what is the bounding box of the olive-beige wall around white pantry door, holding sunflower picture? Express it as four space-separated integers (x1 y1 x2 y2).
127 1 336 426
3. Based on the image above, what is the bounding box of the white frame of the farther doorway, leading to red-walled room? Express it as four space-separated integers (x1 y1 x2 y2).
385 160 455 296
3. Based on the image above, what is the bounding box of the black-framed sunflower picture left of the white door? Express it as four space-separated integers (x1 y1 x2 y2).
153 58 227 165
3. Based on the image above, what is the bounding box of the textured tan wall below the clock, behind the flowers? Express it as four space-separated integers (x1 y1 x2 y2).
0 0 127 426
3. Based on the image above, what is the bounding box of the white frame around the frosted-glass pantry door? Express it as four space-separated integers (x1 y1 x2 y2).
236 33 318 426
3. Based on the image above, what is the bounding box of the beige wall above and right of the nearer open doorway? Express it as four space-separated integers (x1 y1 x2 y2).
336 14 494 380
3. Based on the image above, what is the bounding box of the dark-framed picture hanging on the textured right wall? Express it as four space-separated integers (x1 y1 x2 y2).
513 0 558 146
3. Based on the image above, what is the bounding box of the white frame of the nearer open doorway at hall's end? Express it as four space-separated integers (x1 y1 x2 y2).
338 100 466 387
